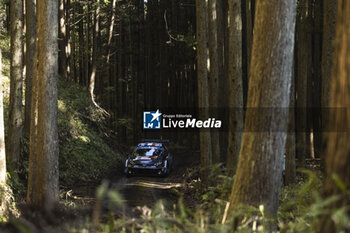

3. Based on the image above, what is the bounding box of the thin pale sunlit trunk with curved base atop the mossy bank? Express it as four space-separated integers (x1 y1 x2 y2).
89 0 101 105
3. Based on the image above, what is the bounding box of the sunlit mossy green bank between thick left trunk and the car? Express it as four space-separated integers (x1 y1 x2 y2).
58 80 121 186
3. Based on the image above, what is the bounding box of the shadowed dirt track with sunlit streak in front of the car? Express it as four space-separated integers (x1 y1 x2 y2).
69 149 200 216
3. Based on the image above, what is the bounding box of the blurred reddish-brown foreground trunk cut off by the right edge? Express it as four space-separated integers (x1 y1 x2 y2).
320 0 350 233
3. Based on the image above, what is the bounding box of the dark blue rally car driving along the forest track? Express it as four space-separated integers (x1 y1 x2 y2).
124 139 173 176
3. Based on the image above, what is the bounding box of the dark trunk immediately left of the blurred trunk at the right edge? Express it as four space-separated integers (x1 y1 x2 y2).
321 0 338 167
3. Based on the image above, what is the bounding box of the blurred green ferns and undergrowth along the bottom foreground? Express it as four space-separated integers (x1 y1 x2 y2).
90 168 350 233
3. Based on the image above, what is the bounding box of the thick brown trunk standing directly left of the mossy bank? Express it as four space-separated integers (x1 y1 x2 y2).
35 0 58 211
